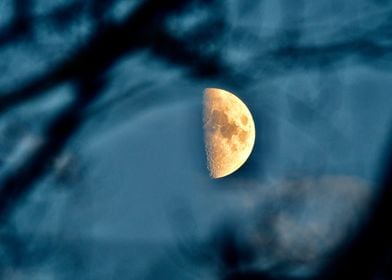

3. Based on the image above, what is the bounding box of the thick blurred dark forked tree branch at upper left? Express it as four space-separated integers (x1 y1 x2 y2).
0 0 230 222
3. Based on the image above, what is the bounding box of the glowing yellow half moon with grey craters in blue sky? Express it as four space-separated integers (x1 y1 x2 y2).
203 88 256 178
